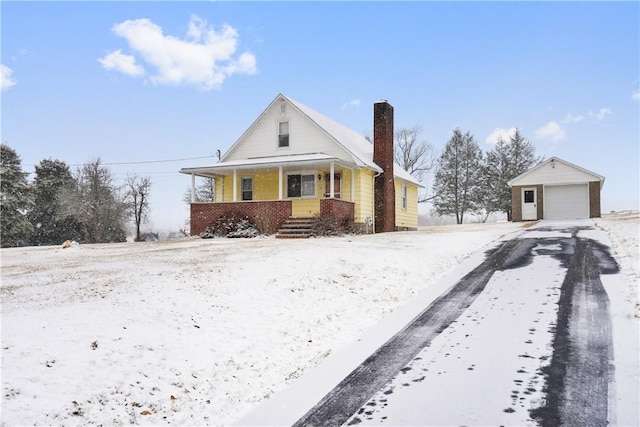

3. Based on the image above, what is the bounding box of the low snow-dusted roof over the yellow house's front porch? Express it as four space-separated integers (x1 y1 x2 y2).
180 153 364 178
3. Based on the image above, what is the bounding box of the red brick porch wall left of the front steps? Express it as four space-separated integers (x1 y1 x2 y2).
190 200 291 236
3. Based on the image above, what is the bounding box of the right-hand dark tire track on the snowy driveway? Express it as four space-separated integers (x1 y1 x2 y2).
531 236 618 426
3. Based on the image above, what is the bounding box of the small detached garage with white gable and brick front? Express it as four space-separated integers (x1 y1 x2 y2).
507 157 604 221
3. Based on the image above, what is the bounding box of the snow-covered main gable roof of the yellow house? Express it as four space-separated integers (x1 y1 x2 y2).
216 93 422 187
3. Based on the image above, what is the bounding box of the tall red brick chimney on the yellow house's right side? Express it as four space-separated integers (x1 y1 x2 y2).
373 100 396 233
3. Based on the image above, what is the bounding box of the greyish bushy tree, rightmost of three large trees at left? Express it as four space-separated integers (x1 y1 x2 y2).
64 159 127 243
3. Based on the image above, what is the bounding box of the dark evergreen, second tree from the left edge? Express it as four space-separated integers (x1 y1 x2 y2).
29 159 83 245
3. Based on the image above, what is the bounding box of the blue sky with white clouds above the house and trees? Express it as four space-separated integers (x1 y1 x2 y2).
0 1 640 230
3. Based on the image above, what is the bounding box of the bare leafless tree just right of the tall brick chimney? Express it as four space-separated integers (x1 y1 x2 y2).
393 125 435 203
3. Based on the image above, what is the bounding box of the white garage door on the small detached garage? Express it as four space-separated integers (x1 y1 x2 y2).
544 184 589 219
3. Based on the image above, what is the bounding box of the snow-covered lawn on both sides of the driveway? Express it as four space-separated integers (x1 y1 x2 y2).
0 214 640 425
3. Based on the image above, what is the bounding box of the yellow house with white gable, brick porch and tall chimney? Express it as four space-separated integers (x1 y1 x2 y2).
180 94 421 235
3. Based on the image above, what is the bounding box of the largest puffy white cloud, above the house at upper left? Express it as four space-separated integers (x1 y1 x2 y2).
101 15 257 89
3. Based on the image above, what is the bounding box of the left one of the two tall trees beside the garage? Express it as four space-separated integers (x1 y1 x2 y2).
433 128 482 224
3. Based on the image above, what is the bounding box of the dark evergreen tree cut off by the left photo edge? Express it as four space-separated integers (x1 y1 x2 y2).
0 144 33 247
